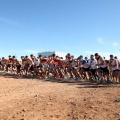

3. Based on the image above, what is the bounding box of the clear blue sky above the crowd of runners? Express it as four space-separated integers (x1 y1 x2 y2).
0 0 120 58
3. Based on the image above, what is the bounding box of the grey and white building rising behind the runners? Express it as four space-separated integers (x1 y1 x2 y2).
38 51 67 59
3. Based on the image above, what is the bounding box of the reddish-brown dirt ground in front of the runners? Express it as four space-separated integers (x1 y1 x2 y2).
0 72 120 120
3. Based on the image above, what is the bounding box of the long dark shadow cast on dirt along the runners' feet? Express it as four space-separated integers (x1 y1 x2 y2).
0 72 120 88
